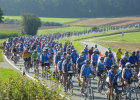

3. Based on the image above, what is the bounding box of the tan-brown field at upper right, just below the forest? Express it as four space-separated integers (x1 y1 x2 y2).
71 17 140 26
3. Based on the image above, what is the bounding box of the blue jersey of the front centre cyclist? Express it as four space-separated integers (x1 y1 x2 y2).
81 64 94 77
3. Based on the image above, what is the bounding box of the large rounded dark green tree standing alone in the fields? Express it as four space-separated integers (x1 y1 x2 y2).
22 13 41 35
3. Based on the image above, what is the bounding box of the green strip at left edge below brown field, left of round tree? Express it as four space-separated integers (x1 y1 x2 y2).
0 29 21 39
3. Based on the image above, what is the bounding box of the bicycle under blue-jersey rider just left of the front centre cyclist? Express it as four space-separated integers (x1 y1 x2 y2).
66 71 74 93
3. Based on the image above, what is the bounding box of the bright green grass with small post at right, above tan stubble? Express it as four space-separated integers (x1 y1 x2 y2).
93 32 140 42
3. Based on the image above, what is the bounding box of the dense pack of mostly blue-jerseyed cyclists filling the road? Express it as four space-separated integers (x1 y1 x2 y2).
3 35 140 100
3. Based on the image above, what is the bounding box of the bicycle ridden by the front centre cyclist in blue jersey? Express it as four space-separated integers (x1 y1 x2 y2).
83 75 94 100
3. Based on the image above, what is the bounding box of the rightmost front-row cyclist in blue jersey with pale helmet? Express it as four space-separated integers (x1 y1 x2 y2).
122 62 134 95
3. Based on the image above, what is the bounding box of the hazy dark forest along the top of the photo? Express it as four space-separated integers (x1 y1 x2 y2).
0 0 140 17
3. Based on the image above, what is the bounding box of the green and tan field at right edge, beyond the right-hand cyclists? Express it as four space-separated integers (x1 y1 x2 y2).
93 32 140 52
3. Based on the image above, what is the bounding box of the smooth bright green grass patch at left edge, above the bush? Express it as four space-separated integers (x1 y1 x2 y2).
0 68 19 82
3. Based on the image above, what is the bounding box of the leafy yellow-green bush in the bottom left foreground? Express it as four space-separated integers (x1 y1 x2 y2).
0 76 62 100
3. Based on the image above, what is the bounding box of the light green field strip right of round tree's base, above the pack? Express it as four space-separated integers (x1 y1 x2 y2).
37 26 92 35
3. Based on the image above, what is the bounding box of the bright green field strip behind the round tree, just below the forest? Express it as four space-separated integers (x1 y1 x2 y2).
4 16 80 24
